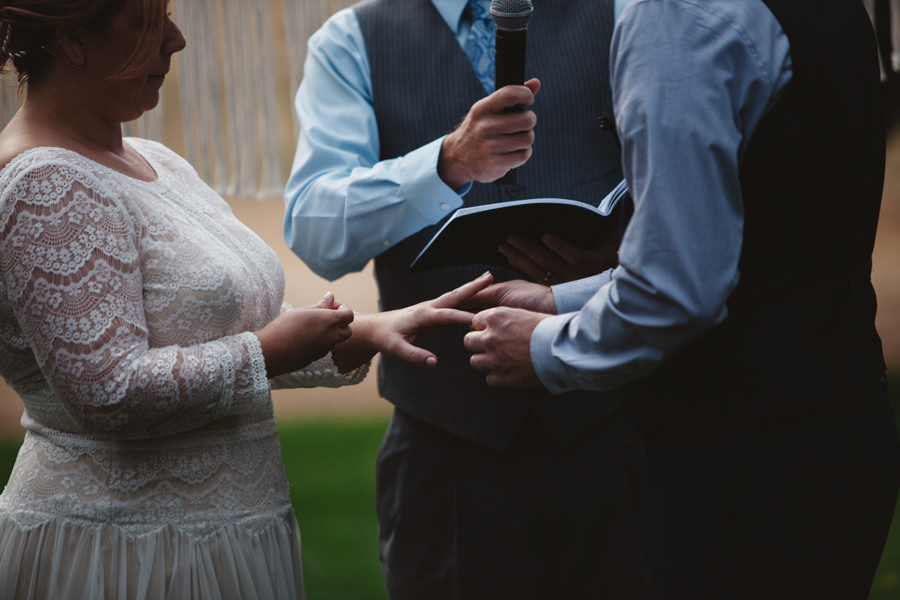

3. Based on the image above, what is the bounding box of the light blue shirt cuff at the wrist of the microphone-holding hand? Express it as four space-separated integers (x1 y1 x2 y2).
400 137 472 224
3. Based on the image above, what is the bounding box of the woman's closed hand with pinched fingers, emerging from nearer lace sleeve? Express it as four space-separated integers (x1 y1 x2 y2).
254 292 353 379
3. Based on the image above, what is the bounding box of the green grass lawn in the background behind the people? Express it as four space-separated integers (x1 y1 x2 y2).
0 372 900 600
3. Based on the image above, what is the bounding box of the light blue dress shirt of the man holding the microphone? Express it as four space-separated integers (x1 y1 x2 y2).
284 0 471 280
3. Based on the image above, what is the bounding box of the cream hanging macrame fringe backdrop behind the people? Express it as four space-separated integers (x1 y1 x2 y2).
0 0 900 199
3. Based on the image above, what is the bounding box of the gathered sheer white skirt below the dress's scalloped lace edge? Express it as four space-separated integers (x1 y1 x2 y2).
0 512 306 600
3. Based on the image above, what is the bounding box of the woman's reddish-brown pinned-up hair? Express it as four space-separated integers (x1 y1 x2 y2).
0 0 168 83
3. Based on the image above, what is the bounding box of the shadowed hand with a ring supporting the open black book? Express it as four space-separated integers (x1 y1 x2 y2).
498 233 619 285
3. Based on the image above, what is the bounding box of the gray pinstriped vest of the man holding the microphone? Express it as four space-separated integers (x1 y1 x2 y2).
354 0 622 449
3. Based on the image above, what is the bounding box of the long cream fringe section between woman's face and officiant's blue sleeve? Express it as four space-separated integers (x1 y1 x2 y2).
179 0 284 199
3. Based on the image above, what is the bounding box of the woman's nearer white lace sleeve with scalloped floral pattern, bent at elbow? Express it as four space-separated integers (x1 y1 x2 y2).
0 164 269 437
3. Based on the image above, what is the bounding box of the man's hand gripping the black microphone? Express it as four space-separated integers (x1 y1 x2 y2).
437 79 541 190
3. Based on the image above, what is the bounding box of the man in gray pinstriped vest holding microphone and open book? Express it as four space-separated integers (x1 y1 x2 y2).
285 0 644 600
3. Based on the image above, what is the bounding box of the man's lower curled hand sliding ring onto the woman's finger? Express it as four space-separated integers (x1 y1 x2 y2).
464 308 549 387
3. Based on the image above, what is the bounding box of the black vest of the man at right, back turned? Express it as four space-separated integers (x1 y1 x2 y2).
627 0 885 434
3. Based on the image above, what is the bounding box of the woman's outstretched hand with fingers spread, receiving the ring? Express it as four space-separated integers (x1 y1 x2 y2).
353 273 493 367
